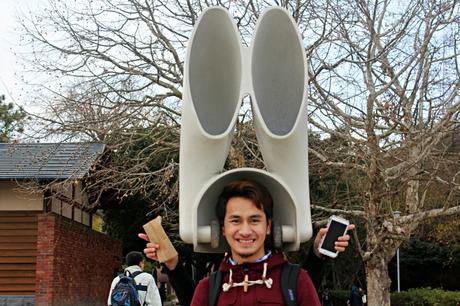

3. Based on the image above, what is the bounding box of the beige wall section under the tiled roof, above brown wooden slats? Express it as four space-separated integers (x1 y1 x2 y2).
0 181 43 211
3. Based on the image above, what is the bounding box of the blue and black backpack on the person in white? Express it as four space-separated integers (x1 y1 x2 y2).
110 270 147 306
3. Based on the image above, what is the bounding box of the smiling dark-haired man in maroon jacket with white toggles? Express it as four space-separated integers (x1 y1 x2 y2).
191 181 320 306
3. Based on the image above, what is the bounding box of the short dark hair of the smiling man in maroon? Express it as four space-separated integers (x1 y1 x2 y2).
216 180 273 224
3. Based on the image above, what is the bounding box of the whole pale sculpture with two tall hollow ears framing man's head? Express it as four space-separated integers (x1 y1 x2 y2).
179 7 311 252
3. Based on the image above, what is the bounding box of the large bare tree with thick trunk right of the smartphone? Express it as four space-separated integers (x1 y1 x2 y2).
309 1 460 305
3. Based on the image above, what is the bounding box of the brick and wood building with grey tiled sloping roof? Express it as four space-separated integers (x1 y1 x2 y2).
0 143 122 306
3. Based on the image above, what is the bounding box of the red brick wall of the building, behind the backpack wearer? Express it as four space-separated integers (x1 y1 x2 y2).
35 213 122 306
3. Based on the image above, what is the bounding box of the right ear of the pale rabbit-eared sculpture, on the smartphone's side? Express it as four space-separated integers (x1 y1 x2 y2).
250 7 312 250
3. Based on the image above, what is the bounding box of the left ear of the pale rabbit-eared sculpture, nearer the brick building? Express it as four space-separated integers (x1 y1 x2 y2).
179 6 243 252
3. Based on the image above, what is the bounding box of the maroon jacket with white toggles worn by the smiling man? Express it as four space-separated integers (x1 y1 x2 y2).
191 253 320 306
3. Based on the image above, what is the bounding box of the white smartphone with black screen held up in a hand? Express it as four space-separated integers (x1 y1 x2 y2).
318 215 350 258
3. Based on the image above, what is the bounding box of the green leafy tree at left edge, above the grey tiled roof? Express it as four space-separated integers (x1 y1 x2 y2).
0 95 27 142
